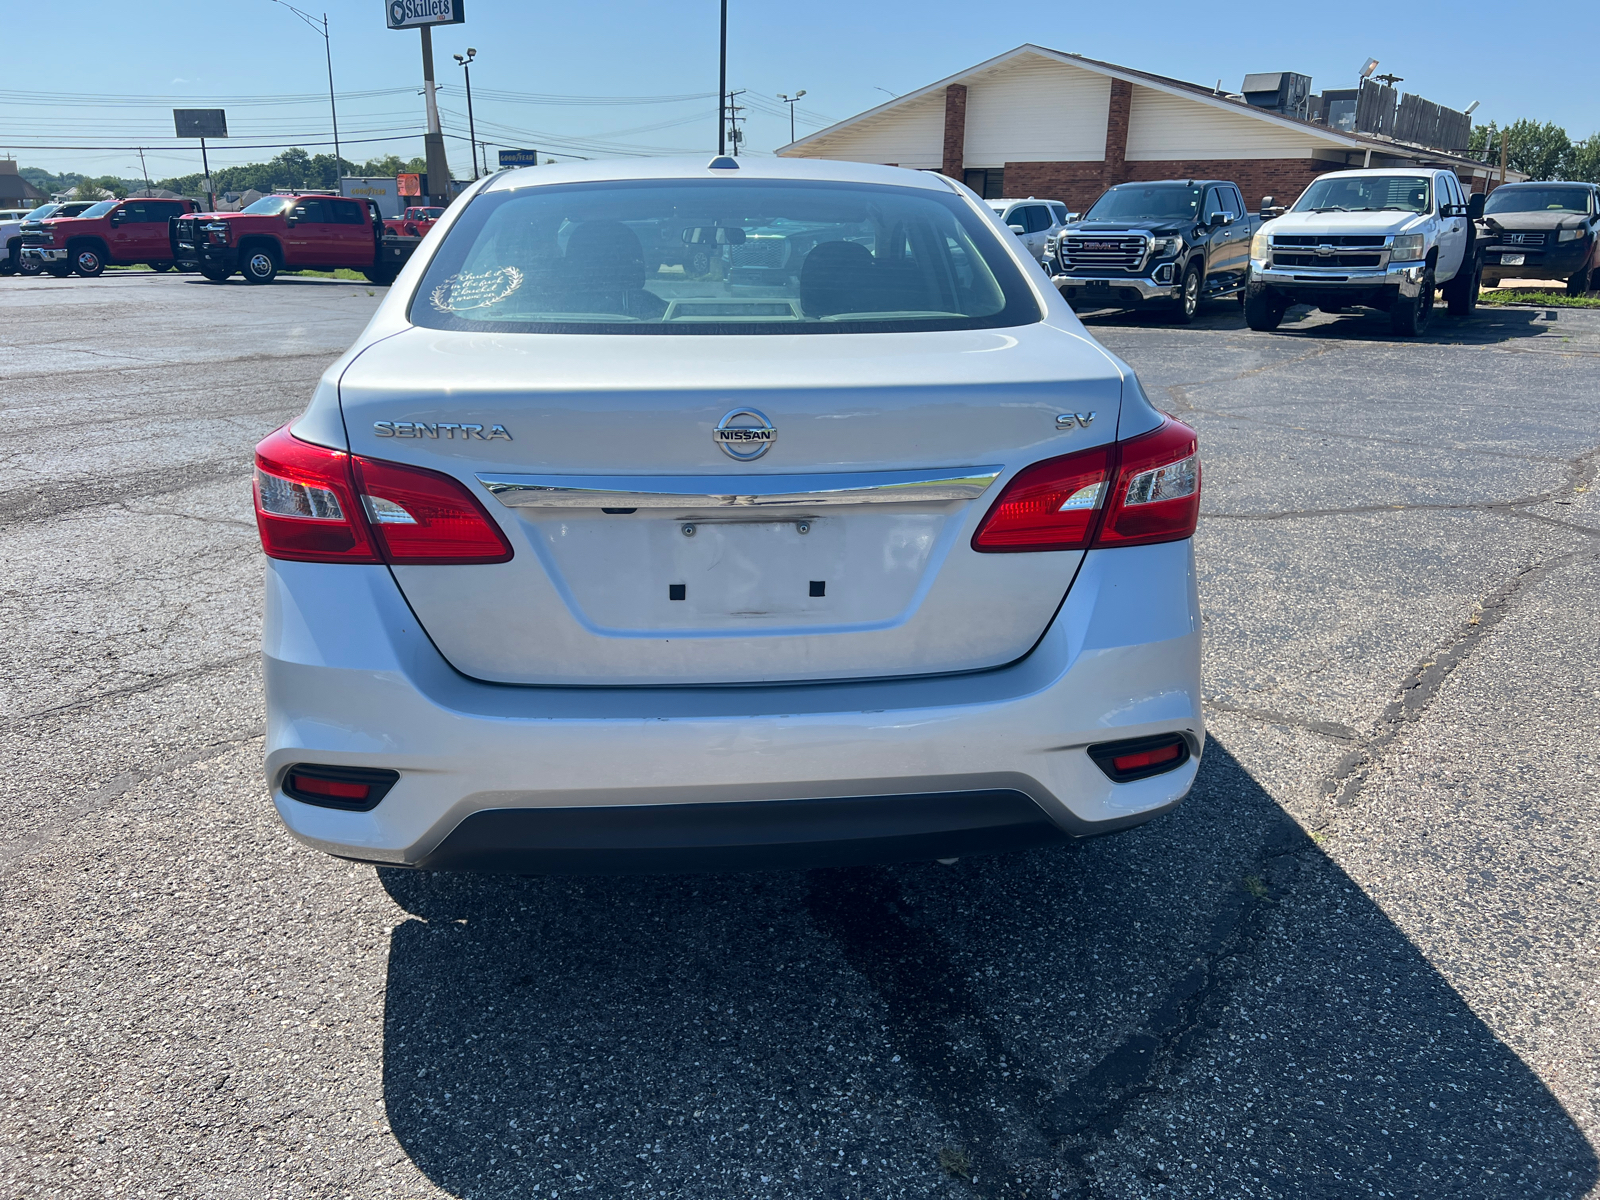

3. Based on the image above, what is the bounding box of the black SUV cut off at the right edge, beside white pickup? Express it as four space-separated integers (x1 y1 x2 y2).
1478 182 1600 293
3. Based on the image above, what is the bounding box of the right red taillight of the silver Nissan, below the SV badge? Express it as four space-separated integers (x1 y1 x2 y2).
973 418 1200 554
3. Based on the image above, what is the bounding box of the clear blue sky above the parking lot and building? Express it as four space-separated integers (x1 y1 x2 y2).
0 0 1600 178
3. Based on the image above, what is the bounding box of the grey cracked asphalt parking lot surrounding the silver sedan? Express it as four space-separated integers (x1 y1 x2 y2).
0 274 1600 1200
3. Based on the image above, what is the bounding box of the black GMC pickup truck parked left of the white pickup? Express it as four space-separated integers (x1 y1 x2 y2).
1045 179 1259 325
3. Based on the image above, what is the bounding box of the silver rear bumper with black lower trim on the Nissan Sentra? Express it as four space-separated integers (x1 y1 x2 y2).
264 542 1205 872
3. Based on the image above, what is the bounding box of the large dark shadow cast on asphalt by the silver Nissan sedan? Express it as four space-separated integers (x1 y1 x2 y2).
379 739 1600 1200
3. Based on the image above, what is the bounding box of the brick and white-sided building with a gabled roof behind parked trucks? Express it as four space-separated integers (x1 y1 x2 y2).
778 45 1491 211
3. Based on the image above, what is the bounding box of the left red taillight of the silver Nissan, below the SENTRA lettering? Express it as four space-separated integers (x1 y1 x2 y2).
254 426 512 565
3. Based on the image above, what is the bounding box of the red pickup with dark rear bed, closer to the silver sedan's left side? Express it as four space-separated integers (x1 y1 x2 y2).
173 194 418 285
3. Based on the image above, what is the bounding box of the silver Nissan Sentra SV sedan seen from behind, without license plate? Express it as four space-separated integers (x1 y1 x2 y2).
254 158 1205 874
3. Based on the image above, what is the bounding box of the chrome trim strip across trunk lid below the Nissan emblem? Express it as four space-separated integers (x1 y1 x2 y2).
478 467 1003 509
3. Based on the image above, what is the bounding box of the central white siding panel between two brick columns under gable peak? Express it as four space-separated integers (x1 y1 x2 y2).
965 54 1110 166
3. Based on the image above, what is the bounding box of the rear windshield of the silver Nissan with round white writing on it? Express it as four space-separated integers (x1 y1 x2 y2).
411 179 1040 334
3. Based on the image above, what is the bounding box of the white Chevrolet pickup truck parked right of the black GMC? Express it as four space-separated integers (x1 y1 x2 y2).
1245 168 1483 338
